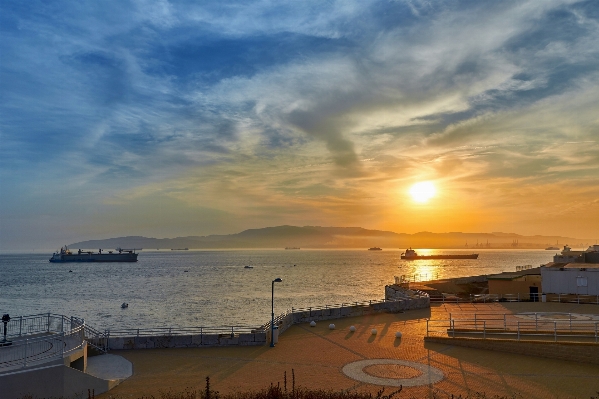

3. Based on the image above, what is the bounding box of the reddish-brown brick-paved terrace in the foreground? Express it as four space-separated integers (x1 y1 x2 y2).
100 303 599 399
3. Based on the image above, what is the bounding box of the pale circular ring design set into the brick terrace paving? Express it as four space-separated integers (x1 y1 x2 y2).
342 359 445 387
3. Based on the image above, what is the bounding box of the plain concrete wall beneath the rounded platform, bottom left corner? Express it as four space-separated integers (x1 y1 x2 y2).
0 364 117 399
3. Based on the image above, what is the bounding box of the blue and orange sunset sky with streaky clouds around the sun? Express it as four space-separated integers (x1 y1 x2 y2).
0 0 599 250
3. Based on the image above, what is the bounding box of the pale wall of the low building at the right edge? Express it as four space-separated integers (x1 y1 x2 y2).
541 263 599 295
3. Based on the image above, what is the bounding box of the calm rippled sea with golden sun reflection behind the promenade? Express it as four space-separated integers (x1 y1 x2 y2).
0 249 553 329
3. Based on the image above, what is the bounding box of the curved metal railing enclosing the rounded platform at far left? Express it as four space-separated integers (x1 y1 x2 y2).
0 314 86 373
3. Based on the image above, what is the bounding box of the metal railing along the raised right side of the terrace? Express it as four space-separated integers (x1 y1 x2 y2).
426 313 599 343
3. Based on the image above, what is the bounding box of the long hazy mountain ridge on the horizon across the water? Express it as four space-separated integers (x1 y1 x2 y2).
69 226 594 249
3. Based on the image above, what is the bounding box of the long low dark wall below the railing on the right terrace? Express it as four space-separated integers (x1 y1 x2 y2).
424 337 599 364
